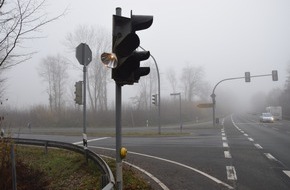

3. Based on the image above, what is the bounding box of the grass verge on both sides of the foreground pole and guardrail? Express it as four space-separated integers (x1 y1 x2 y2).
16 146 152 190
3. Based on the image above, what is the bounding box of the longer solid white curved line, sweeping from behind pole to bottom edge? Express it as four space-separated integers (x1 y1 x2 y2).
89 146 234 189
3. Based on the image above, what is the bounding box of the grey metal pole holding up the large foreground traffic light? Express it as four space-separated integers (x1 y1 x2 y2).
116 7 123 190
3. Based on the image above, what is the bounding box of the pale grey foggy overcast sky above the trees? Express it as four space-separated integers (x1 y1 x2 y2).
7 0 290 107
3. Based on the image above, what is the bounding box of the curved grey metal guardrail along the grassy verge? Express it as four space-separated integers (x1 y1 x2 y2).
12 138 115 190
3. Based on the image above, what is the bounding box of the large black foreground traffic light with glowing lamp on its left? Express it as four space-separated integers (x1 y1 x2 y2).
109 12 153 85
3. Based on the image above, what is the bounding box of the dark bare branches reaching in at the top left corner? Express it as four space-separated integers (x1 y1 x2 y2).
0 0 64 69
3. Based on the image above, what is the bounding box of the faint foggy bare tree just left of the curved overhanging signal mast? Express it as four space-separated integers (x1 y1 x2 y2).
180 66 204 101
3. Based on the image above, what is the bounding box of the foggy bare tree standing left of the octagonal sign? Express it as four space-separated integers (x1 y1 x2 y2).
38 55 68 114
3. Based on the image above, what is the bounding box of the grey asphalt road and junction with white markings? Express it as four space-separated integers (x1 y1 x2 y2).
14 114 290 190
